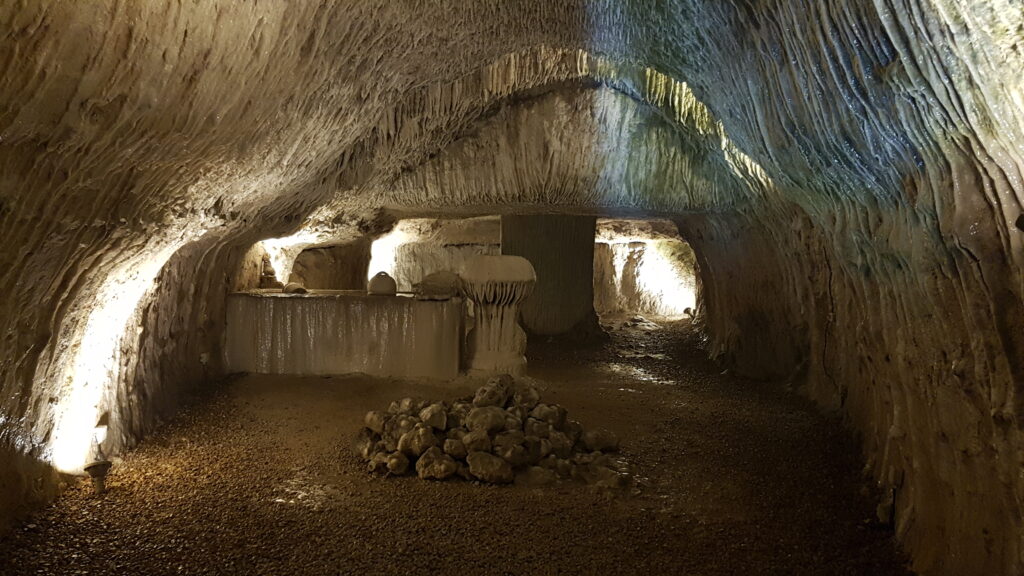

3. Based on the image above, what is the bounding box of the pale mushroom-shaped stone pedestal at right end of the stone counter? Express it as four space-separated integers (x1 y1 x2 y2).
460 256 537 376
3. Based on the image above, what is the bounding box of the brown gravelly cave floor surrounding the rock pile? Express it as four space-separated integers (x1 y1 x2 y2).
0 322 907 576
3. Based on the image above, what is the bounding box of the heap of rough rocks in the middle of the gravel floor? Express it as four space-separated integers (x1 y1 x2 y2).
353 375 631 488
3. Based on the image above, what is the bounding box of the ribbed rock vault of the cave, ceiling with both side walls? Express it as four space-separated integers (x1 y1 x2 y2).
0 0 1024 575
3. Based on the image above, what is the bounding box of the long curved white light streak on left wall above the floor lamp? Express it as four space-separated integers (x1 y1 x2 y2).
48 231 205 474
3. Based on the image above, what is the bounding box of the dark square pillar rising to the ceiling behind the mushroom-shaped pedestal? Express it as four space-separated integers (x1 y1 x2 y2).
502 214 599 335
